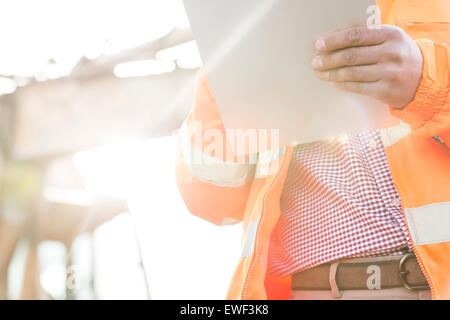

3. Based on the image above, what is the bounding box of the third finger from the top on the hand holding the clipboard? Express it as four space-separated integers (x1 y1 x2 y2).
318 65 383 82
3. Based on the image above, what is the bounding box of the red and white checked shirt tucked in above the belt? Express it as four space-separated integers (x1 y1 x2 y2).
268 131 409 276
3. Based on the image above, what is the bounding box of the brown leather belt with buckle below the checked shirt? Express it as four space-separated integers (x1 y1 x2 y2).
292 253 428 290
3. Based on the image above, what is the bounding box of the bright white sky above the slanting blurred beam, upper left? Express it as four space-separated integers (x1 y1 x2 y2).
0 0 189 77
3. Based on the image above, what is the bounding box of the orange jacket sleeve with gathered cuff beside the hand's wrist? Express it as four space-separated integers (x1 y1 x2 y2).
391 39 450 146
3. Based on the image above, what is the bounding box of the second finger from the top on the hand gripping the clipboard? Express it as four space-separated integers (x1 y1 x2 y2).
311 46 382 71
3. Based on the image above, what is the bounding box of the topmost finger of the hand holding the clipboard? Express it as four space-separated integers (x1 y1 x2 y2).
316 26 391 52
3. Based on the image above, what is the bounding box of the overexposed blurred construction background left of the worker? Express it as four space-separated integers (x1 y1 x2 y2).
0 0 241 299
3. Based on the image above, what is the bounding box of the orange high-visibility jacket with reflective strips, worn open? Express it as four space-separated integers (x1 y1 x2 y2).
176 0 450 299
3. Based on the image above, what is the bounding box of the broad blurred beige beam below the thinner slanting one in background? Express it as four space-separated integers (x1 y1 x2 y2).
11 69 196 160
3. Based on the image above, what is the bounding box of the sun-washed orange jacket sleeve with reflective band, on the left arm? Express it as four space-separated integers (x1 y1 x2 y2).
176 69 254 225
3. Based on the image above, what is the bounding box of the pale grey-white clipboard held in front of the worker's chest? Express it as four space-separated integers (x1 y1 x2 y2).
184 0 399 146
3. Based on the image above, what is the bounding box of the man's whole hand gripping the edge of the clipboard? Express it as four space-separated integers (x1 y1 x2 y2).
311 25 423 109
